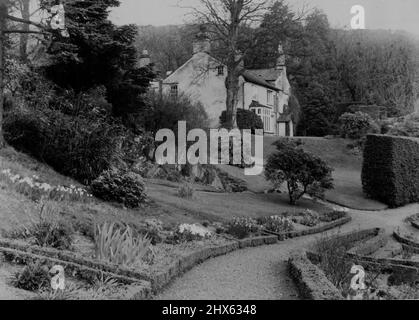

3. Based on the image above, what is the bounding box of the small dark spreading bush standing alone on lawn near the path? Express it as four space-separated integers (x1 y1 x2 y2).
265 140 333 205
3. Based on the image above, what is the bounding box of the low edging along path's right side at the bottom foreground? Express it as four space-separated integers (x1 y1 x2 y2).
288 252 343 300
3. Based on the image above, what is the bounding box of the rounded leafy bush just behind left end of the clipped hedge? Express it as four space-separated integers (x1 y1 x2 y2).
339 111 379 139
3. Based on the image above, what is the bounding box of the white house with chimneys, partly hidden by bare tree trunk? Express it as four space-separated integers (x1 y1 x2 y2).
153 29 294 136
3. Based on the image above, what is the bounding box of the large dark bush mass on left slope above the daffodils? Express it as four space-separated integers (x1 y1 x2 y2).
4 108 122 184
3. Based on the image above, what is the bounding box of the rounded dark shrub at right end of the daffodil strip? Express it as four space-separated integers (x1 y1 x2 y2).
91 169 146 208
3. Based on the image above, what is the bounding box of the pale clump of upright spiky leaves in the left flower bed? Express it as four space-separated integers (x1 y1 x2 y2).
95 223 151 266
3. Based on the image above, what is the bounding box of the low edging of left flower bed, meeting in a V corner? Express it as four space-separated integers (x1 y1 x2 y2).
0 235 278 299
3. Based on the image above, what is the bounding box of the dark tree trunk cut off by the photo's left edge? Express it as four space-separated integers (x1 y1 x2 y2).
0 0 8 149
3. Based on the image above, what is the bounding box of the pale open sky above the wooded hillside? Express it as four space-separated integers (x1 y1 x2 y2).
111 0 419 34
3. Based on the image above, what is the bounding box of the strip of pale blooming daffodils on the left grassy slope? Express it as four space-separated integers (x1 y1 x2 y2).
0 169 92 201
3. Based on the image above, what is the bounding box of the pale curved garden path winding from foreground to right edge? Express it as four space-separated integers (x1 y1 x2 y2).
155 204 419 300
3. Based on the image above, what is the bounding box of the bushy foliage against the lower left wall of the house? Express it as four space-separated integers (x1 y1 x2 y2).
143 93 208 133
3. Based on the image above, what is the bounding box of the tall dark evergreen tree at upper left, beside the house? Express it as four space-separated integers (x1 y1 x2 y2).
42 0 154 118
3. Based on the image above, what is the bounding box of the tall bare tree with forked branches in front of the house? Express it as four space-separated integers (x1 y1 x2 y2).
191 0 268 128
